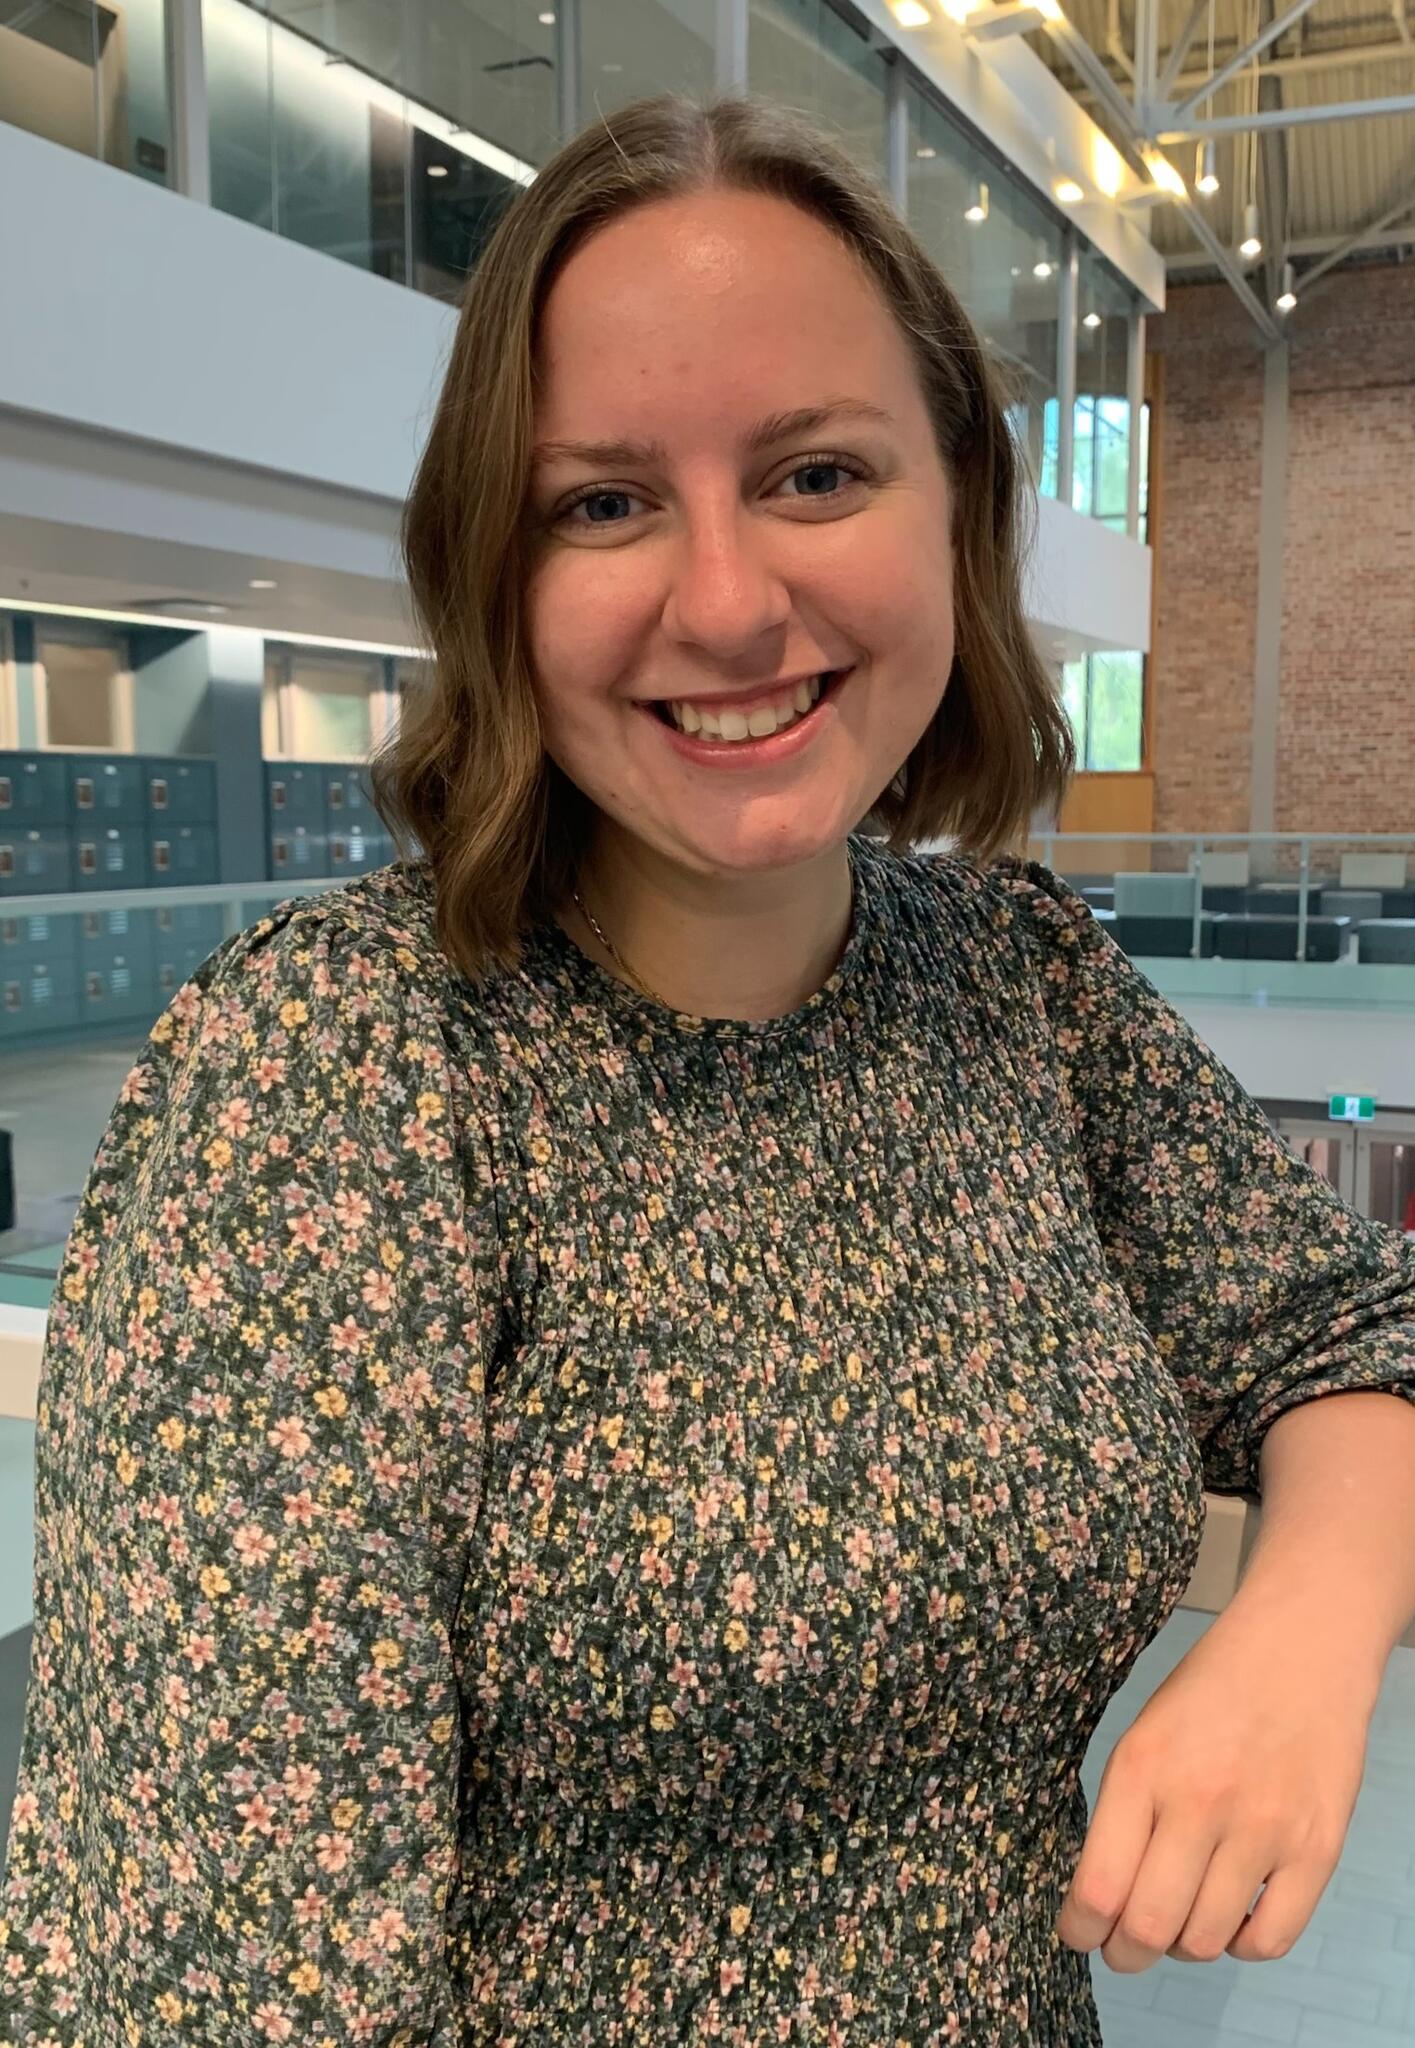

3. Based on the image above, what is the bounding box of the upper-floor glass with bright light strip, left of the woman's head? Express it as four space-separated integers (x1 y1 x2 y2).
203 0 557 297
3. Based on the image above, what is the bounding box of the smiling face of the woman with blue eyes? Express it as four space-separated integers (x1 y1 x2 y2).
528 190 954 874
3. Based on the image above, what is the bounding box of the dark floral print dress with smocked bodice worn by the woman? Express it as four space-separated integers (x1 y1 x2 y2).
0 836 1415 2048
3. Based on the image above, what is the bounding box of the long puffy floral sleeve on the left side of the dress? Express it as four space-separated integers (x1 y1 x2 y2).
0 897 509 2048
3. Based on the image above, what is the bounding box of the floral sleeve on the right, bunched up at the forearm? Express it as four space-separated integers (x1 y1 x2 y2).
991 856 1415 1497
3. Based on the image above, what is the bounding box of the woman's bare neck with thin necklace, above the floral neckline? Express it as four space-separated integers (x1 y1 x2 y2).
557 846 854 1020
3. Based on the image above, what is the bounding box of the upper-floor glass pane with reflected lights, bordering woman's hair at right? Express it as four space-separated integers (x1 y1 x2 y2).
907 82 1064 510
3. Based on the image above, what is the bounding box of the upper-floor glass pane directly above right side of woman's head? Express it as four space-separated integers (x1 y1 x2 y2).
747 0 889 184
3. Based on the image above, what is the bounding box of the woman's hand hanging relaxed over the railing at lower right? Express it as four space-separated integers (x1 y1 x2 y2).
1057 1595 1380 1972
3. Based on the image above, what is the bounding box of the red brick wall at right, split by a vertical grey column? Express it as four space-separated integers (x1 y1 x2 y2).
1149 264 1415 834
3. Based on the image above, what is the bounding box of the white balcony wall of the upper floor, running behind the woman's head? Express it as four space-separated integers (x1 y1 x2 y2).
0 125 1149 653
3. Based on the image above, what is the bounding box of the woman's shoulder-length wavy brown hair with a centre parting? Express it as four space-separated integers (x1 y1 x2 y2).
369 92 1075 979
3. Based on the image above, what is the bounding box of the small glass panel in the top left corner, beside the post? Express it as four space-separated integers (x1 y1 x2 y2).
0 0 172 184
